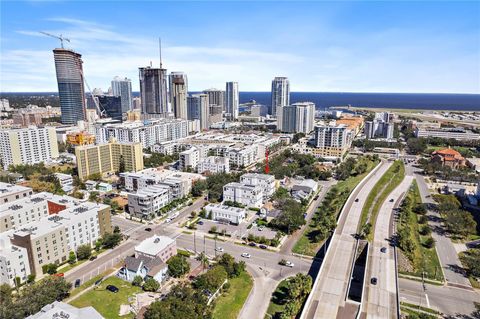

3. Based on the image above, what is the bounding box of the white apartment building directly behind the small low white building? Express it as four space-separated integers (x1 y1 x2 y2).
223 182 263 208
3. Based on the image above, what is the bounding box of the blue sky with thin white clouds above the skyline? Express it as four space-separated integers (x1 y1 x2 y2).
0 0 480 93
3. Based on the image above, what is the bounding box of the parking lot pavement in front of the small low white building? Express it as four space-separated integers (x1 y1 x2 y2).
192 219 277 239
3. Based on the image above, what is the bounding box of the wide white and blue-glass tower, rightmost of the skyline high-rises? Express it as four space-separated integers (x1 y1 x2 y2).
280 102 315 134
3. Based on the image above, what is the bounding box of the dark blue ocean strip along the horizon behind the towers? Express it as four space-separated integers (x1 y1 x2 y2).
0 91 480 112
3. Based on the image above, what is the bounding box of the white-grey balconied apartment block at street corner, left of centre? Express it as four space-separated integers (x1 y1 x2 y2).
128 185 171 219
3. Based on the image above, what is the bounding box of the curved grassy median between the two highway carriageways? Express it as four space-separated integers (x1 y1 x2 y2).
357 161 405 241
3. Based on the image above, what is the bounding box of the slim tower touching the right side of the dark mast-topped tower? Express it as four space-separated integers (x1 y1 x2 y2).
169 72 188 120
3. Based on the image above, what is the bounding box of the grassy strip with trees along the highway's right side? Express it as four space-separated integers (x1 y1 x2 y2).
402 182 444 281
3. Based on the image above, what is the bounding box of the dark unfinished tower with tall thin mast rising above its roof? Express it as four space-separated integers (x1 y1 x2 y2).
139 67 168 117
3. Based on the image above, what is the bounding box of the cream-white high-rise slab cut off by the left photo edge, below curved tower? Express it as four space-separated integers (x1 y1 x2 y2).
0 126 58 169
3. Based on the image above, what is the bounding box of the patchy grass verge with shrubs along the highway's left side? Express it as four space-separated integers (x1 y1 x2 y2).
292 161 378 256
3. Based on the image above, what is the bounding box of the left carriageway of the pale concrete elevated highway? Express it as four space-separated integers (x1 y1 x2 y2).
300 162 391 319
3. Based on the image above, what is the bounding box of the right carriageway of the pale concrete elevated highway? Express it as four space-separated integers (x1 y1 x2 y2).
362 175 413 319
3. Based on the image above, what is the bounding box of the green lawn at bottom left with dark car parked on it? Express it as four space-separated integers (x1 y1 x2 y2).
70 277 142 319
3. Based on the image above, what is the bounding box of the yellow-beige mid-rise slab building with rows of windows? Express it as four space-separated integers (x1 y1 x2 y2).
75 140 143 180
